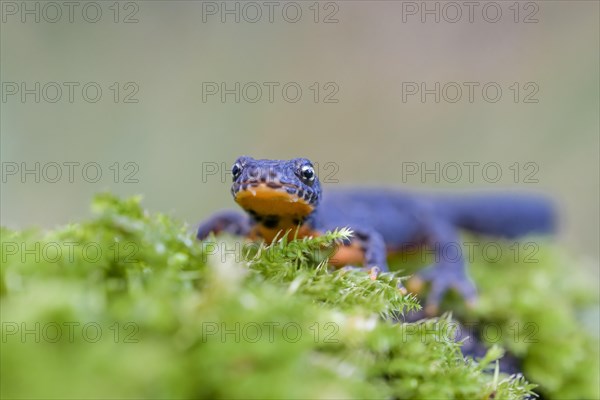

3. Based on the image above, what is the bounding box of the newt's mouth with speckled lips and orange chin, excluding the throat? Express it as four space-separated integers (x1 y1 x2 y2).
231 180 316 219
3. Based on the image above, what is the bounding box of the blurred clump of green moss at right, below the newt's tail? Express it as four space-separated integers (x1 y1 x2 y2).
473 242 600 399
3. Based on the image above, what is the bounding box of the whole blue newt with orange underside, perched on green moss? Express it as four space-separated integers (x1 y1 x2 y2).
197 157 555 313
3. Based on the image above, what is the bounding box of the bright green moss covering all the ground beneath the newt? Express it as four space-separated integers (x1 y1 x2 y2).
0 195 599 399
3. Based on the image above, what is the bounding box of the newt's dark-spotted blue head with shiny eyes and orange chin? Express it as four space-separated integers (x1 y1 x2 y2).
231 157 321 241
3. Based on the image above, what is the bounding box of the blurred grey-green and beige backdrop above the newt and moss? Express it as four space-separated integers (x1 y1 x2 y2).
0 1 600 275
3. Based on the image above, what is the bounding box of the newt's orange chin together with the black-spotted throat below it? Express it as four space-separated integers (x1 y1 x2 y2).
235 184 314 243
